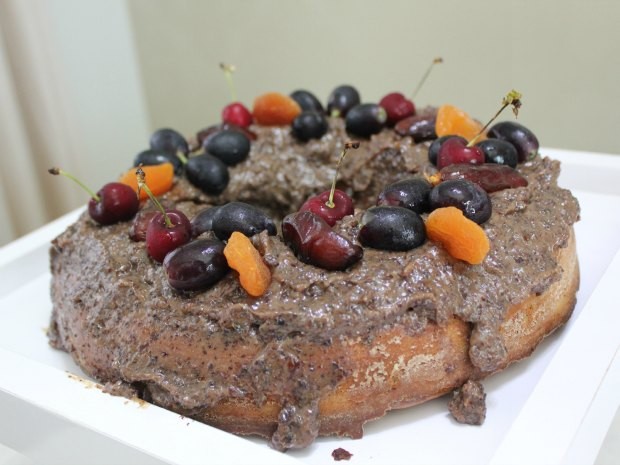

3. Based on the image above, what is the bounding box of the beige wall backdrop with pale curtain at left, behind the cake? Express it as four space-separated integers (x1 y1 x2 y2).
0 0 620 245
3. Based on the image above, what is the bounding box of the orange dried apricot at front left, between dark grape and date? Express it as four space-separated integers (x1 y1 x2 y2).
224 231 271 297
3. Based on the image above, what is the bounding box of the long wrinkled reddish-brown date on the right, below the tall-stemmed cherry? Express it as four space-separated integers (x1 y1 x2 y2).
439 163 527 193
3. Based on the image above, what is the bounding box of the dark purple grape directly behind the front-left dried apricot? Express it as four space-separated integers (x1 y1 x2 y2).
212 202 277 240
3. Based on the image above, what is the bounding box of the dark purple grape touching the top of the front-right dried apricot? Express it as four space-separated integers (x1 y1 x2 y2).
429 179 491 224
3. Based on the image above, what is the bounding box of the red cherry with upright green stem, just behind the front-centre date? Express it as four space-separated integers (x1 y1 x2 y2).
299 141 360 226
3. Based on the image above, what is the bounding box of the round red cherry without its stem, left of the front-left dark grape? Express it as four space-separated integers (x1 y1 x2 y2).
146 209 192 262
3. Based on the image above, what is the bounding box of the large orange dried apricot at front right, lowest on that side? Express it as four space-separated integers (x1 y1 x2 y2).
426 207 491 265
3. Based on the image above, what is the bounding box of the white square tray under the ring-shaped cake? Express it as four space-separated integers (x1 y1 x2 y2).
0 149 620 465
